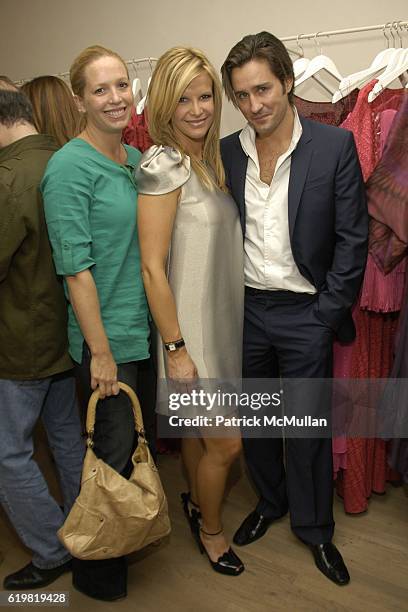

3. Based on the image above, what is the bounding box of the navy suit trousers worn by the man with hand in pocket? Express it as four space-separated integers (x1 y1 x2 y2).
243 288 334 544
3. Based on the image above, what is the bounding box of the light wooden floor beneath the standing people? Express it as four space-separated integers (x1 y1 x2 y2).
0 432 408 612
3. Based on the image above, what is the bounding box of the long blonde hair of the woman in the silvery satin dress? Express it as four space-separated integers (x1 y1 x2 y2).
147 47 227 191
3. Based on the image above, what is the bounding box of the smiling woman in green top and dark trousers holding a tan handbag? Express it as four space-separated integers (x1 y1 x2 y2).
41 46 155 600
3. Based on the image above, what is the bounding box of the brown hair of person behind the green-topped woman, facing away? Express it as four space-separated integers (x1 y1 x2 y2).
21 76 83 147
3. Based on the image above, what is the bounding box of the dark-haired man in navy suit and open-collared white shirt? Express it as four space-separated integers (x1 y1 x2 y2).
221 32 368 584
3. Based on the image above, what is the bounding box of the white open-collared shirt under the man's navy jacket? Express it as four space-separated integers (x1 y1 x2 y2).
239 108 316 294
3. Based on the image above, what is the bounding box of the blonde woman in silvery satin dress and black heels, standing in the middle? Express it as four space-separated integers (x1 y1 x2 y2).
136 47 244 575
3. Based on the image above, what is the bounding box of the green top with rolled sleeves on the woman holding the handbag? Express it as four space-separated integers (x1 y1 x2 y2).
41 138 149 363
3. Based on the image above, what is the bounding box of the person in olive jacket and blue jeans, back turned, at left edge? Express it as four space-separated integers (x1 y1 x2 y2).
0 77 84 590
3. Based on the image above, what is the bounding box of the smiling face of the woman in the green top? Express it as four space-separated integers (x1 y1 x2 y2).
77 56 133 133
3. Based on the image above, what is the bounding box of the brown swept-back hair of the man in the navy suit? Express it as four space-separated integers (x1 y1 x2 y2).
221 32 295 106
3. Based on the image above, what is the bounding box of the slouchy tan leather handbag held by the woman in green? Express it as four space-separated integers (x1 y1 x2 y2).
58 383 170 559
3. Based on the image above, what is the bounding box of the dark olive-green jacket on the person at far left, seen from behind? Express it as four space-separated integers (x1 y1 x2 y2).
0 134 72 379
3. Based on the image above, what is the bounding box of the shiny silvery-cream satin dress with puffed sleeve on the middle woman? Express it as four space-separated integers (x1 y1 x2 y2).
136 146 244 392
